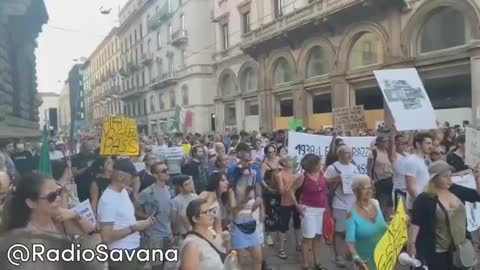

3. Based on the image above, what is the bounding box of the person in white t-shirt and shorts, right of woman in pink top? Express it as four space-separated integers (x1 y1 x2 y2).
324 145 360 267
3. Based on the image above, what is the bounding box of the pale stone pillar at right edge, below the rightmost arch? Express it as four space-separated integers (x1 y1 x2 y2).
470 40 480 127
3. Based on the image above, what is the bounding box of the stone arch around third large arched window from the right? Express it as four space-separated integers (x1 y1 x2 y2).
297 38 336 79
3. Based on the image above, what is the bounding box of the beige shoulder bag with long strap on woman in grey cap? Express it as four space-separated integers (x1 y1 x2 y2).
437 198 477 270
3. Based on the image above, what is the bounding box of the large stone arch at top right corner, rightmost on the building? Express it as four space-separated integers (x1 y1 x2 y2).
401 0 480 57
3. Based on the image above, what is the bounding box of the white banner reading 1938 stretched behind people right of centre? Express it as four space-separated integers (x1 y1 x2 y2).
288 132 375 174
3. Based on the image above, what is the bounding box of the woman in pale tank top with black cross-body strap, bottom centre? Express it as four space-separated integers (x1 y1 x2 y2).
179 199 230 270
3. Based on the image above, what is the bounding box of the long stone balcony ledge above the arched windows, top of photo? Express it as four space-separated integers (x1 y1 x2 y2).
241 0 368 50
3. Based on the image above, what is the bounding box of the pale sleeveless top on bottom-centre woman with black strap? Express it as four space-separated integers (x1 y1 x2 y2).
180 234 225 270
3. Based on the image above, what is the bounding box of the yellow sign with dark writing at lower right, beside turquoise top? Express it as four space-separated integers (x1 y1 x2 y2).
374 200 408 270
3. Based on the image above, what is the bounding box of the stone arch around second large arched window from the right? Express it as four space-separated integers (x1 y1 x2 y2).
336 22 390 72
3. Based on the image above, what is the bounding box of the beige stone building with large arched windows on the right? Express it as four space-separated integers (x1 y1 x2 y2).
213 0 480 129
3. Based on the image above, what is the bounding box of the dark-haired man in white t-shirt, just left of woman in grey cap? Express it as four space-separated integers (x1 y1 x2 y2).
403 133 433 209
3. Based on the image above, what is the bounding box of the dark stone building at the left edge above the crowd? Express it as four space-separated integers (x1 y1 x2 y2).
0 0 48 138
